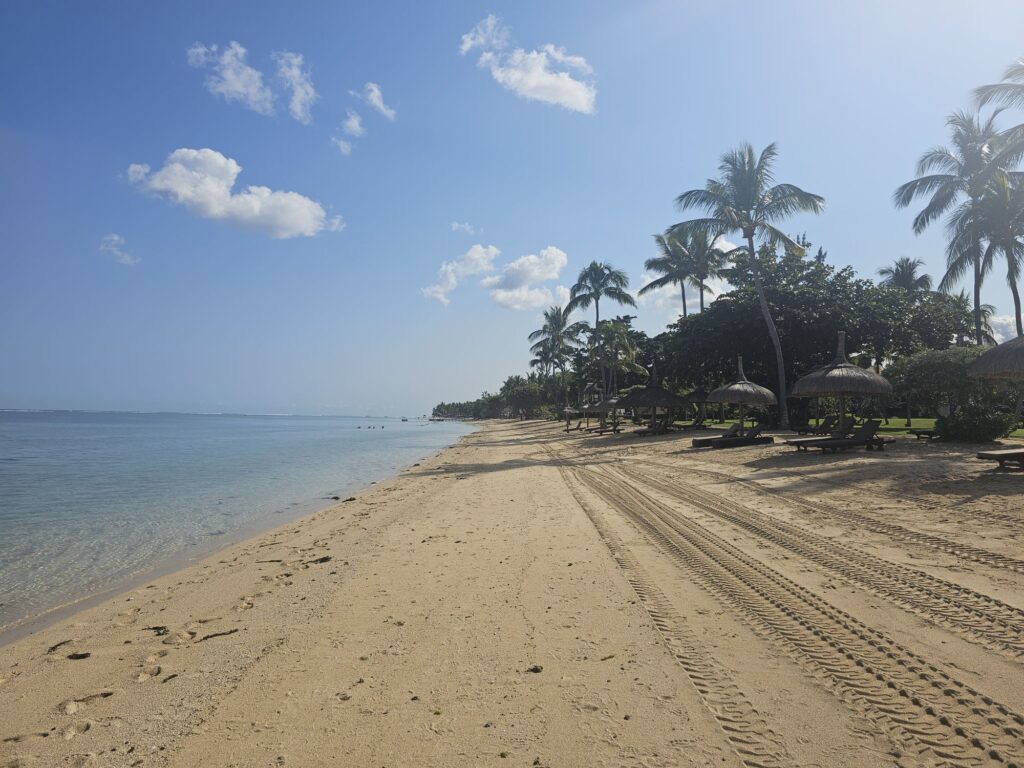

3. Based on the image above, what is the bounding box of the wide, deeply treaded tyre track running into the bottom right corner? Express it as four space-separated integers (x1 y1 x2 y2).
573 468 1024 768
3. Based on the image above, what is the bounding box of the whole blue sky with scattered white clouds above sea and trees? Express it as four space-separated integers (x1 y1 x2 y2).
0 0 1024 416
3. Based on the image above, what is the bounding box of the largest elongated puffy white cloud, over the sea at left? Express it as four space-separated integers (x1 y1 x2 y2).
128 148 343 239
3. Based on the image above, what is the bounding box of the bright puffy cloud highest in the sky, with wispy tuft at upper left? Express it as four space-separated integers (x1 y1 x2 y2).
459 15 597 115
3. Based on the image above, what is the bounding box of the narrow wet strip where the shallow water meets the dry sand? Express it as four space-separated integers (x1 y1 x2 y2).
0 428 475 649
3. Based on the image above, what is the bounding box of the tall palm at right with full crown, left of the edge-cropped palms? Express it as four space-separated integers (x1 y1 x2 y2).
893 112 1006 344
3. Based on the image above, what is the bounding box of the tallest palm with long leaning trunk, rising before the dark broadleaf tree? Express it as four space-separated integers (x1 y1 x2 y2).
673 143 825 428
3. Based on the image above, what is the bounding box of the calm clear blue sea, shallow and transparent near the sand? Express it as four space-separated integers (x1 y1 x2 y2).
0 411 471 632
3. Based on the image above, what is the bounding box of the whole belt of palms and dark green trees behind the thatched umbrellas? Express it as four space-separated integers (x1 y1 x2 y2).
435 59 1024 439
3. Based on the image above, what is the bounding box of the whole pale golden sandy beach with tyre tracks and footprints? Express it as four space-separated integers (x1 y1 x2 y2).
0 422 1024 768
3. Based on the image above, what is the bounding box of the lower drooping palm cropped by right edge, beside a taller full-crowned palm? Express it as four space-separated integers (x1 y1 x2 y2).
940 173 1024 336
